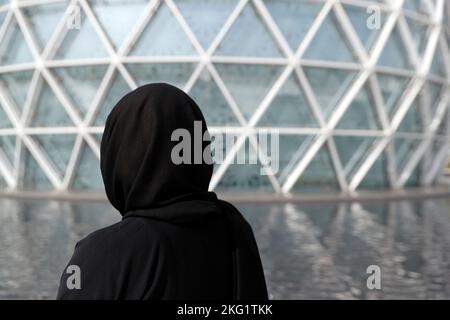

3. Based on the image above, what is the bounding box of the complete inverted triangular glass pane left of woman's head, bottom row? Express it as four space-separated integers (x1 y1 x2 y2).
33 134 75 176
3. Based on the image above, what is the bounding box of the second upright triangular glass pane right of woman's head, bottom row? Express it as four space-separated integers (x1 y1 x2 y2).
292 144 340 193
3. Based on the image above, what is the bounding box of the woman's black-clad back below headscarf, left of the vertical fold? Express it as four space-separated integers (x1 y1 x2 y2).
58 206 233 300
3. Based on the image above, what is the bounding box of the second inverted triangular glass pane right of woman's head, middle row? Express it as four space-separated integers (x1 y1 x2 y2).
303 67 356 118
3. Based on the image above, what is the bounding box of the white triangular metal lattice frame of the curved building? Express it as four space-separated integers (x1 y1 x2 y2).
0 0 450 195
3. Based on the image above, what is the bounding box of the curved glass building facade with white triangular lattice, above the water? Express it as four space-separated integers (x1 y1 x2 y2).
0 0 450 194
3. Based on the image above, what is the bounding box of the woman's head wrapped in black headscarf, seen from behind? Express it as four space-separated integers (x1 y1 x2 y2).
100 83 213 214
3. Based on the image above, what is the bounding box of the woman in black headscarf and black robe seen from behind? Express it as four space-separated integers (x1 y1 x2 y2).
57 84 267 299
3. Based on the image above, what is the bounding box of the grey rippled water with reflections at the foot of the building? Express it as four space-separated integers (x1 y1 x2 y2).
0 199 450 299
